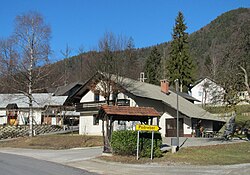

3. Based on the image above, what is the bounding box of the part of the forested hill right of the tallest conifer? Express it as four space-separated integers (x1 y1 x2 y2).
189 8 250 79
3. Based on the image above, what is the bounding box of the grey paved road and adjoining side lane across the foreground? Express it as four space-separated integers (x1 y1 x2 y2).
0 147 250 175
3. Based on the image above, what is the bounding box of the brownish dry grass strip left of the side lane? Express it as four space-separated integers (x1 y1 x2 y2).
0 134 103 149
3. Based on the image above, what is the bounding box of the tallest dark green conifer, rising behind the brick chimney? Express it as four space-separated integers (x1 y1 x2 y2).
168 12 195 91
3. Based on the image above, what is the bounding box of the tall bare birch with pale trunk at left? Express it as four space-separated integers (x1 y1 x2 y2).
1 12 51 136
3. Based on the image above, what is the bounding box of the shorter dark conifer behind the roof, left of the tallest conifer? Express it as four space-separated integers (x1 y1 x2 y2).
144 47 161 85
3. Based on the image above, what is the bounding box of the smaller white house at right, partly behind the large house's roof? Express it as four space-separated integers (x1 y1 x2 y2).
190 78 224 105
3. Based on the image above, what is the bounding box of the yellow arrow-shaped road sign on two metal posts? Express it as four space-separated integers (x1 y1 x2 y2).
135 124 161 160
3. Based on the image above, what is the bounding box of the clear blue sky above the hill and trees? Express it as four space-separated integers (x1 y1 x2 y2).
0 0 250 61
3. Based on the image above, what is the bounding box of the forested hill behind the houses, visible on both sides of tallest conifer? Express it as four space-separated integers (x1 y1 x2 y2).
48 8 250 88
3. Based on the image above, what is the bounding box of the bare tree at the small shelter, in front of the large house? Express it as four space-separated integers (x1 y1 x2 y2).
86 33 137 152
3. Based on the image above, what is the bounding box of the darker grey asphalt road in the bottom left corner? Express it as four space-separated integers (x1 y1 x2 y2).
0 153 97 175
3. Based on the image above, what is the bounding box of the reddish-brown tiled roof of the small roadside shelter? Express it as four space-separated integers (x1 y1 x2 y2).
101 105 160 117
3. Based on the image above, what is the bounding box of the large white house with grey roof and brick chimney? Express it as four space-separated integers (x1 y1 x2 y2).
75 73 225 137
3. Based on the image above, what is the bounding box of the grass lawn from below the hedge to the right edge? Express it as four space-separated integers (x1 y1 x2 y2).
100 142 250 165
